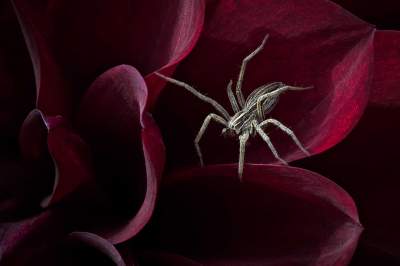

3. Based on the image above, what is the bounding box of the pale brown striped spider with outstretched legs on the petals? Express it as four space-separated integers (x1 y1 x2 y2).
156 34 312 179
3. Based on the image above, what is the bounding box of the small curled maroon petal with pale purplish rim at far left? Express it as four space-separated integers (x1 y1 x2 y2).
20 109 92 207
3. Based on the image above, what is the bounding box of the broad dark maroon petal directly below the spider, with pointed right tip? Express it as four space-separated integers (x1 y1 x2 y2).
137 164 362 265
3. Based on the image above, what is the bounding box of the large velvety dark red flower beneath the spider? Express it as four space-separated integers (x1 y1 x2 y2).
0 0 397 265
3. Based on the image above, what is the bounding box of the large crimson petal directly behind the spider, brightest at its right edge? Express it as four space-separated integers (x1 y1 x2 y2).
156 0 374 169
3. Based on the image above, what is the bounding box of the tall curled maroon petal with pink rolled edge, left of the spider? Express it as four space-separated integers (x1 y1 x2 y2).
77 65 164 243
